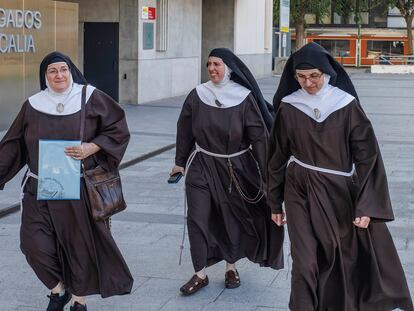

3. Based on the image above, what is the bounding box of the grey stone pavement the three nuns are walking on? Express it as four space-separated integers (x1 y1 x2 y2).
0 71 414 311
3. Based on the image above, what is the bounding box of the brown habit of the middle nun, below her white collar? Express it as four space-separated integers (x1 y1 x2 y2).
175 90 283 271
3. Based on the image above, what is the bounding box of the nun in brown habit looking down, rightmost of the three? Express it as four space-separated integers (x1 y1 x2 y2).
268 43 413 311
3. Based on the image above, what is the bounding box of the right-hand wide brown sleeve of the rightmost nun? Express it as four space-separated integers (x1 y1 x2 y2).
350 101 394 221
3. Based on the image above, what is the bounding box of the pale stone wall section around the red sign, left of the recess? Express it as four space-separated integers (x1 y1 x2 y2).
138 0 202 103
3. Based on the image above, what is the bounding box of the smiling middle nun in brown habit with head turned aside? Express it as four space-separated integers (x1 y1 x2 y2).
171 48 283 295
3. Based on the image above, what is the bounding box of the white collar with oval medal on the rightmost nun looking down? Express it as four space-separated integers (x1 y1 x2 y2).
282 74 355 123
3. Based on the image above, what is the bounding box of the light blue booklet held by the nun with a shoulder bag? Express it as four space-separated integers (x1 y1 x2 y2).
37 139 81 200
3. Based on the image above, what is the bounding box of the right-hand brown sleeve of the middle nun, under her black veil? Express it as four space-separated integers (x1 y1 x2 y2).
244 94 269 182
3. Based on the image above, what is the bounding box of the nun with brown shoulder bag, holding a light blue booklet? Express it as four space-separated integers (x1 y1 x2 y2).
0 52 133 311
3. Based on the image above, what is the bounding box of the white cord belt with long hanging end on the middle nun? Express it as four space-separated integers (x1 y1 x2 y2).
178 143 264 265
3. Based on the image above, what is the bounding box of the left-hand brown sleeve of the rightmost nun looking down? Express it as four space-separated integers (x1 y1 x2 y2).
267 106 291 214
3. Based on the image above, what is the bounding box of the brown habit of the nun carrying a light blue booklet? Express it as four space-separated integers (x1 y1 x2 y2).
0 89 133 297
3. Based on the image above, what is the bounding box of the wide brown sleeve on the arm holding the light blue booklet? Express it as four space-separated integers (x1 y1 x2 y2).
86 89 130 169
